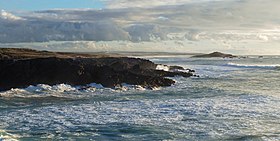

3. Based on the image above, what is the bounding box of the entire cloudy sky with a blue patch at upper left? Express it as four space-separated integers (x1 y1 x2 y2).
0 0 280 55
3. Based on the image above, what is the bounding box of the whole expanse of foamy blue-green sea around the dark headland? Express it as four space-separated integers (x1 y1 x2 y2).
0 56 280 141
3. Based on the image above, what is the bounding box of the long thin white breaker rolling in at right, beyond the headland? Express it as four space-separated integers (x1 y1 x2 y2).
227 63 280 69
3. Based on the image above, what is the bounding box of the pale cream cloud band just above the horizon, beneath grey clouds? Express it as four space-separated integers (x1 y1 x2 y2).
0 40 280 55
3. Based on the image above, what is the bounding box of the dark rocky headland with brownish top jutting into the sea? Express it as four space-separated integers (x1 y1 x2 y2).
0 48 193 90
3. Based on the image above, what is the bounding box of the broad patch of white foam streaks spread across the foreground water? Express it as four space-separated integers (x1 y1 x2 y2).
0 95 280 139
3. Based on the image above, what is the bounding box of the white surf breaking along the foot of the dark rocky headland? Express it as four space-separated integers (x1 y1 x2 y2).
0 83 151 98
